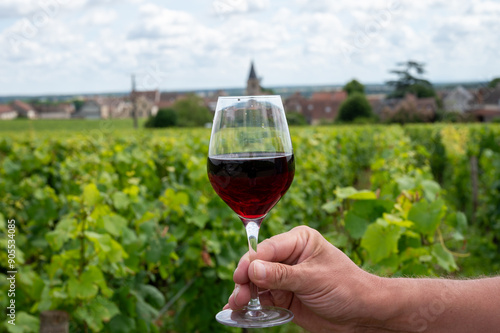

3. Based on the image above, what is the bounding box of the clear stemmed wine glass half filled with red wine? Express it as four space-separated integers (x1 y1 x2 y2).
207 96 295 328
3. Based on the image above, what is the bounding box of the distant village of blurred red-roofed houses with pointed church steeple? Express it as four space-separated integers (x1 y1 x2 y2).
0 62 500 125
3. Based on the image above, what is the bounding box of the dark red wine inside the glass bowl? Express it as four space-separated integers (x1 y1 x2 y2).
207 153 295 219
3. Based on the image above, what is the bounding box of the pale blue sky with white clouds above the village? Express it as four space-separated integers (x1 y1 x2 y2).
0 0 500 96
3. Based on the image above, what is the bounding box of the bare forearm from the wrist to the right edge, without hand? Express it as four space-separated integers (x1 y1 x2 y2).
364 277 500 333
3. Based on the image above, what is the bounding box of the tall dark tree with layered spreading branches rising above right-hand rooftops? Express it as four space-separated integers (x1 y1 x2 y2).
386 60 436 98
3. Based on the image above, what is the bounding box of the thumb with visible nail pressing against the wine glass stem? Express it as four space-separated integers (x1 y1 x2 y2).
248 260 304 292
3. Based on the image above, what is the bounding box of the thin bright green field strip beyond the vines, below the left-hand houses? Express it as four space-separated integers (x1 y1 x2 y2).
0 118 146 133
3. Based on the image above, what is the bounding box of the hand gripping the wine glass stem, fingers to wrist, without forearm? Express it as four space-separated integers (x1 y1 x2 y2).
224 227 378 332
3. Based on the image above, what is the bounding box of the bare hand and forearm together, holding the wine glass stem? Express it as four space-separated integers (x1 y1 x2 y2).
224 227 500 333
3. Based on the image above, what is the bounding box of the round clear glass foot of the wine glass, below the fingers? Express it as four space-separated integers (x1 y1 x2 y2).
215 306 293 328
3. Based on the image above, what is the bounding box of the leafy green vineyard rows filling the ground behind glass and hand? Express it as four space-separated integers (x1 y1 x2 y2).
0 125 500 333
